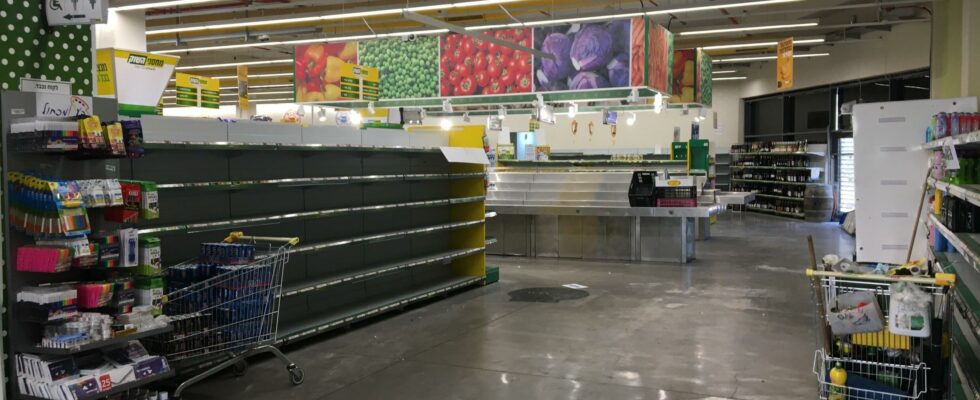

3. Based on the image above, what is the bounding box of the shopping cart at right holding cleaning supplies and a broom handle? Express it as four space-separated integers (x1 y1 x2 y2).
806 269 955 400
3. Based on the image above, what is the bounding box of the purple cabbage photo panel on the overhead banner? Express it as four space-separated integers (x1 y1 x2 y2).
533 20 631 92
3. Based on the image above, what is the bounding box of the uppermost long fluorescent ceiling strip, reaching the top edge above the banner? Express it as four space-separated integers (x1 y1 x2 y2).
146 0 519 35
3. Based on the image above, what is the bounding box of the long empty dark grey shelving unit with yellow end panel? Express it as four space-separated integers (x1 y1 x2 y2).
122 116 487 350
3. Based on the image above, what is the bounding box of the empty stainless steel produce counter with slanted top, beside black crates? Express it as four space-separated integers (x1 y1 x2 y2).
487 171 724 263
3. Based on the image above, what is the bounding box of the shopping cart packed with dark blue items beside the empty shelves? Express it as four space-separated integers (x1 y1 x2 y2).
148 232 304 398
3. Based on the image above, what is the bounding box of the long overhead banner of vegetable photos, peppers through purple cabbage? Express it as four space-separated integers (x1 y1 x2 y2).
295 21 676 103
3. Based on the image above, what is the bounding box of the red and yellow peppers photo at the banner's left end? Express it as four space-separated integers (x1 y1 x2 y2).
294 42 357 103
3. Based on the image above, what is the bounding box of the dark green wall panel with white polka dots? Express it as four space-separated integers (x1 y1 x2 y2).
0 0 93 96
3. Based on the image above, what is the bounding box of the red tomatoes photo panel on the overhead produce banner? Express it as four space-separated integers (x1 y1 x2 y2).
438 28 533 97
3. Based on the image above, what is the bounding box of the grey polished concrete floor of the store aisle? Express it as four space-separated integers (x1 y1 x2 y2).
184 213 854 400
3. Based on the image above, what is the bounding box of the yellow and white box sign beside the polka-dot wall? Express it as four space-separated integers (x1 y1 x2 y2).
95 48 180 116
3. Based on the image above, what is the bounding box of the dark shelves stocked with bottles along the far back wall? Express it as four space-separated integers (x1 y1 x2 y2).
726 142 833 221
